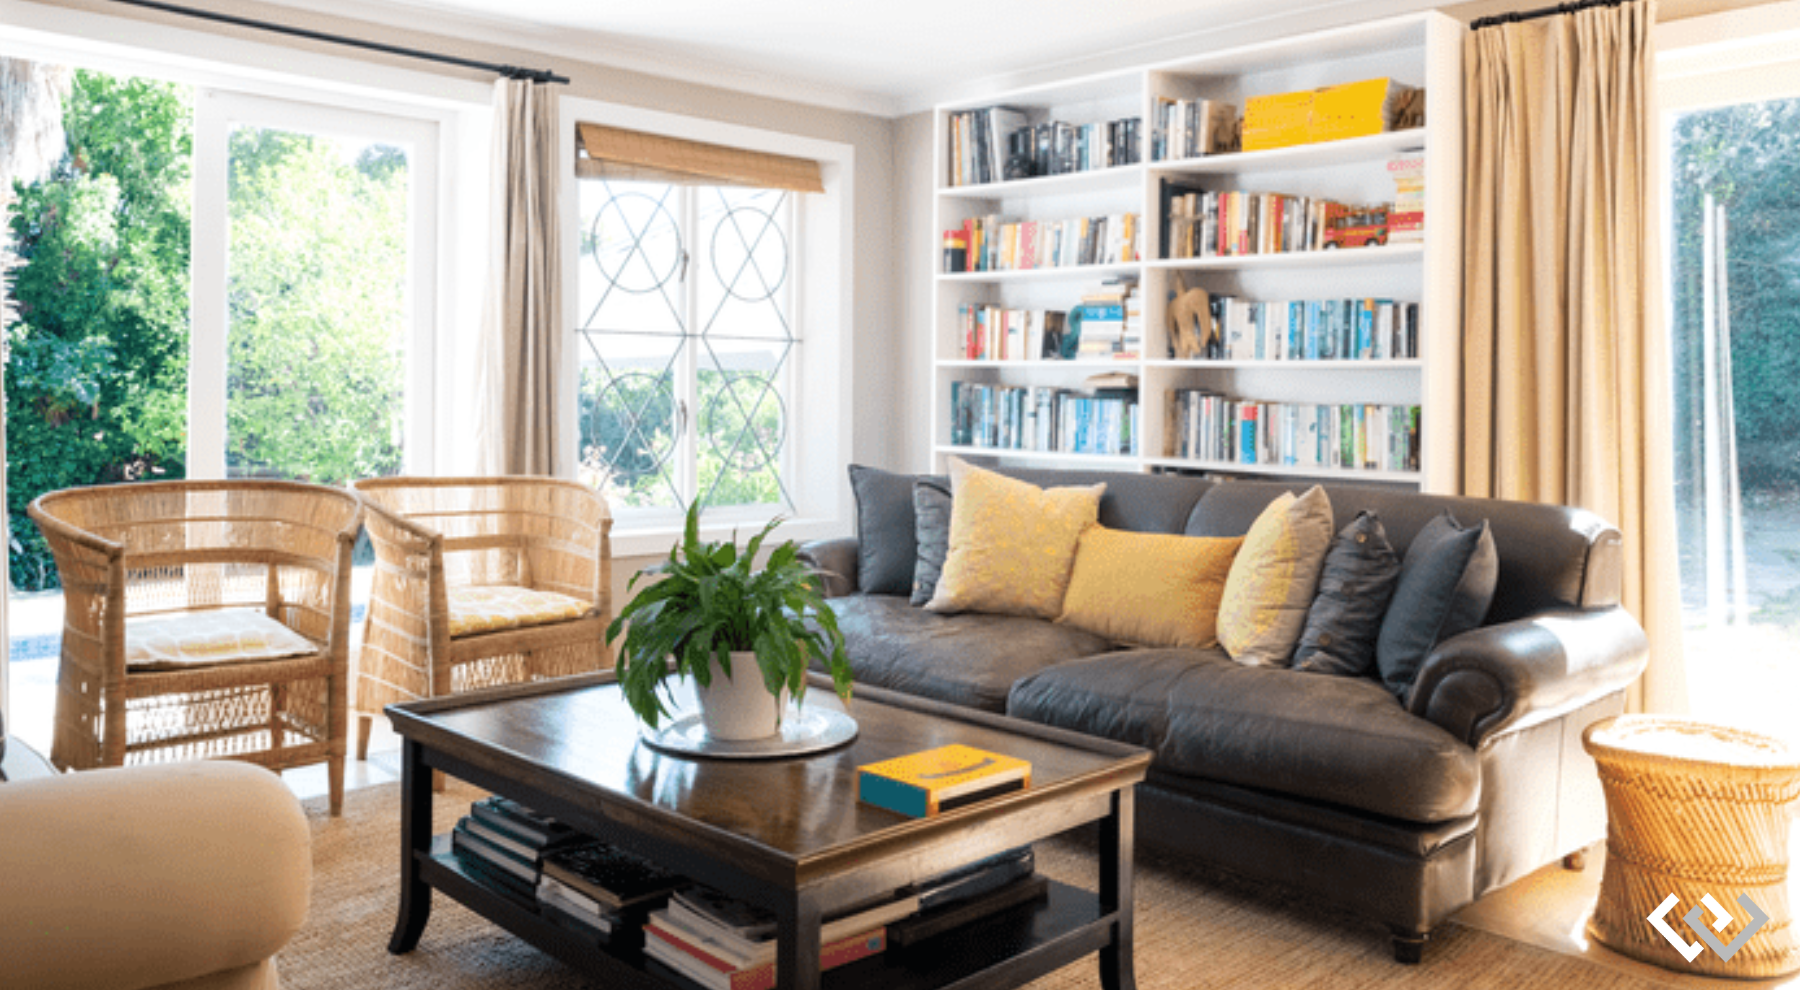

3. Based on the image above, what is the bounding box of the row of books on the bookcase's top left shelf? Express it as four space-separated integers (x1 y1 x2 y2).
949 106 1141 185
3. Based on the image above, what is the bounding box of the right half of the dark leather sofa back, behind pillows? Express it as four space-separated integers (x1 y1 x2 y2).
1184 481 1622 625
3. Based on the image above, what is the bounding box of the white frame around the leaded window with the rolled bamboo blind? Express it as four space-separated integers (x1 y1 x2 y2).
558 97 855 556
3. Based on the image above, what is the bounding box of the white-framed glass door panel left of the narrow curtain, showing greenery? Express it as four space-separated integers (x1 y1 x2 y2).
189 90 437 484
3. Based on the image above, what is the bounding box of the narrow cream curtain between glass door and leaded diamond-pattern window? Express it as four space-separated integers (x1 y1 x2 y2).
477 79 563 475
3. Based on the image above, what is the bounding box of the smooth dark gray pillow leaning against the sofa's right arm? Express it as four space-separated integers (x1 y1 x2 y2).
1375 511 1499 702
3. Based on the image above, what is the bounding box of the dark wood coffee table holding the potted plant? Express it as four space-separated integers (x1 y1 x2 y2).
387 673 1150 990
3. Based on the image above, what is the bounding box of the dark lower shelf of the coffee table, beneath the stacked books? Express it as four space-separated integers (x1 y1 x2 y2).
416 837 1118 990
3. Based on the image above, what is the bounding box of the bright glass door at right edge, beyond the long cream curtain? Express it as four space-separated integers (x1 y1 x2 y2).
1660 14 1800 733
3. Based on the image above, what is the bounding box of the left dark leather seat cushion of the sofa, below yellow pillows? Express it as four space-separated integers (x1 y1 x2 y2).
832 594 1112 711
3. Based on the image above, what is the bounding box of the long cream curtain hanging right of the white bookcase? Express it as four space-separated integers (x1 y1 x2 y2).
1462 0 1687 711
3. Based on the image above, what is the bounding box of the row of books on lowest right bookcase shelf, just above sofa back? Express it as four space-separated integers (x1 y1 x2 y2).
1163 389 1418 472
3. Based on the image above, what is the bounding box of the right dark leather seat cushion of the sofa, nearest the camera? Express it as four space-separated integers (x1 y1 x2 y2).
1006 650 1481 824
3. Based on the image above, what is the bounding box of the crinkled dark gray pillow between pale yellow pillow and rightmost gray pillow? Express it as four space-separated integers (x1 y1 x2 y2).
1294 509 1400 677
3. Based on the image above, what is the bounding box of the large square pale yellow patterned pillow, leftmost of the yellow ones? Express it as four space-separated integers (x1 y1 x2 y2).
925 459 1107 619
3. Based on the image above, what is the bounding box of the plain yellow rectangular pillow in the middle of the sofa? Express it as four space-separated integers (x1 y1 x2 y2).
1058 526 1244 648
